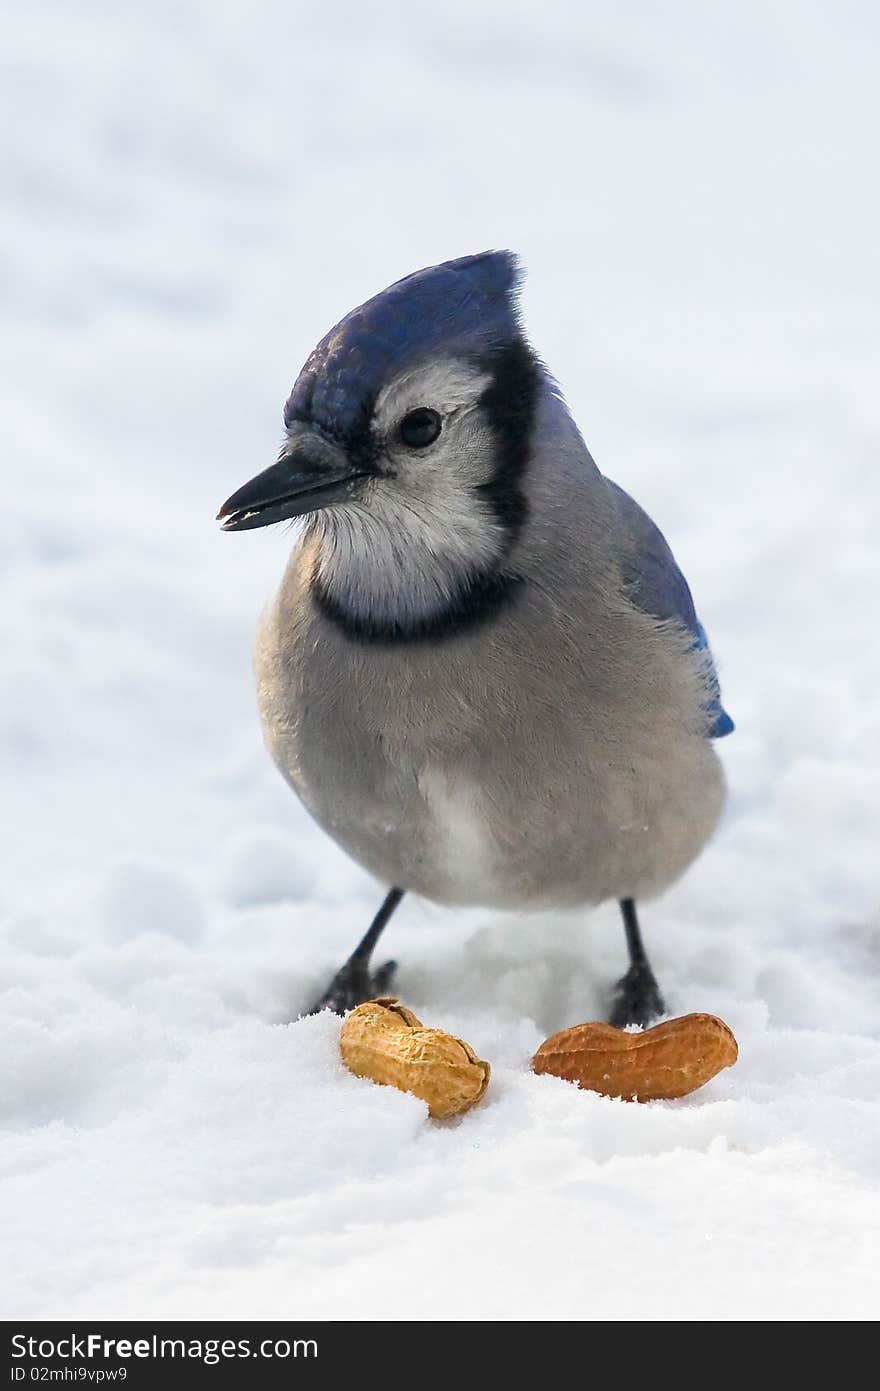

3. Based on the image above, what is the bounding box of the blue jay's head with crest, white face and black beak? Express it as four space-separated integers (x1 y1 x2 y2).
218 252 544 637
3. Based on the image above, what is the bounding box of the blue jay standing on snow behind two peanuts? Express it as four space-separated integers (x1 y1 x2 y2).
218 252 733 1025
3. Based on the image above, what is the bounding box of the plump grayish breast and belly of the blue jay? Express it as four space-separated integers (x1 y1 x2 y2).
256 523 723 907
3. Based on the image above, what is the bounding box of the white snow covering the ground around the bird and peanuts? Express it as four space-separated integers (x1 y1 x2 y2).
0 0 880 1320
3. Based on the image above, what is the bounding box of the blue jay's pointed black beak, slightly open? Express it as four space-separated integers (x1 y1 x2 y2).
217 433 367 531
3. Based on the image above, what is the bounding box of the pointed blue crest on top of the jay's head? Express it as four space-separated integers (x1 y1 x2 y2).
284 252 520 441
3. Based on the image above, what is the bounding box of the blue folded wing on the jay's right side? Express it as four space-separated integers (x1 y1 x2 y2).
606 479 735 739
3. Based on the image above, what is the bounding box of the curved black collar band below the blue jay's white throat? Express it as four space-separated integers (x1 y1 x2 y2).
311 570 525 647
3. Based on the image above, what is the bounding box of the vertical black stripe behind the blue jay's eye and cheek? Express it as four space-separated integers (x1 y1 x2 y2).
475 338 541 541
